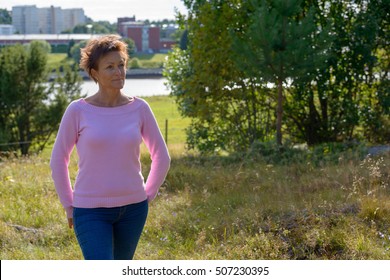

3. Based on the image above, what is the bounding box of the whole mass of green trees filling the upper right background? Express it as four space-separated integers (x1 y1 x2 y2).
165 0 390 152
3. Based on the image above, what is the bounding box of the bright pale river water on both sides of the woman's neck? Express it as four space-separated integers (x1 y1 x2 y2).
81 78 169 97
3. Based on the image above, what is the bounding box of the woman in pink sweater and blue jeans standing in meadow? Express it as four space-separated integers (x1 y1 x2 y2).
50 35 170 259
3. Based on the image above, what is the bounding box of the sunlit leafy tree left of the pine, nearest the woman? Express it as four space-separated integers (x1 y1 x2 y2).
165 2 273 153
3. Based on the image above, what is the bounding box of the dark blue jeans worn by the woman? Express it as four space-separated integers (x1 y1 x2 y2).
73 200 148 260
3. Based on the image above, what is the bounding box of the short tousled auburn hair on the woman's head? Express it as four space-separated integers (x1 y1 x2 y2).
80 34 129 82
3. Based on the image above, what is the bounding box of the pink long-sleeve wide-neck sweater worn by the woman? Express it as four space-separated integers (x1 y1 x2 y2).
50 98 170 218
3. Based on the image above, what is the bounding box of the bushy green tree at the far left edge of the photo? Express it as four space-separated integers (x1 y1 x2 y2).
0 42 48 155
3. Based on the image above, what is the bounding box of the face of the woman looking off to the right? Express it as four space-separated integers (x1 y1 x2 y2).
92 51 126 89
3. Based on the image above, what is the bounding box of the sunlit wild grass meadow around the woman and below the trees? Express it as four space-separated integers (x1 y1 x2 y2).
0 97 390 260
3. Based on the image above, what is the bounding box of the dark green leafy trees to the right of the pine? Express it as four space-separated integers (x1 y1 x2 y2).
286 0 390 145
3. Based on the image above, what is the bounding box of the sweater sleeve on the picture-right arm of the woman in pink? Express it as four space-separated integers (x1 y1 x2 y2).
141 105 171 201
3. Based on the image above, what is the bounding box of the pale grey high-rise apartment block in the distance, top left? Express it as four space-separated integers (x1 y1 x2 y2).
12 5 85 34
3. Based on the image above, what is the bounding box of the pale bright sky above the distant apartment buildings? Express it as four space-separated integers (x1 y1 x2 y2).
0 0 187 23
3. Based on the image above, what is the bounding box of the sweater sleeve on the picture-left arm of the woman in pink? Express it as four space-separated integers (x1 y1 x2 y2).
50 104 78 218
